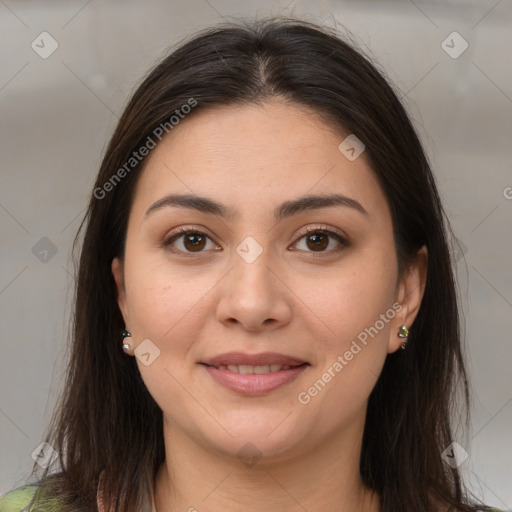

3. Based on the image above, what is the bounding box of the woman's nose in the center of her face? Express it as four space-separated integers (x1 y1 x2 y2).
217 243 293 331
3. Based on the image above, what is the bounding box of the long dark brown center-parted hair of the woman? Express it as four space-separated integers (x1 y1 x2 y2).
33 18 494 512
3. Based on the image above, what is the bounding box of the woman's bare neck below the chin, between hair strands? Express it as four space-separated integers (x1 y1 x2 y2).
155 417 380 512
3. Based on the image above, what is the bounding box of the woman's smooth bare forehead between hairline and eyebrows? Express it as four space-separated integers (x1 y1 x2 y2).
134 100 387 221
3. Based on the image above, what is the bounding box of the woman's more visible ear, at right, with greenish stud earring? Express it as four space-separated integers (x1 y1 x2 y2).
388 246 428 354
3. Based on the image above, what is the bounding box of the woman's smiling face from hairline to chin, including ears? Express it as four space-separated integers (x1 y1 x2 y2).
112 101 423 460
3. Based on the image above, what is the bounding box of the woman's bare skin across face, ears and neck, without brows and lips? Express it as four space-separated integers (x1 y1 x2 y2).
112 100 427 512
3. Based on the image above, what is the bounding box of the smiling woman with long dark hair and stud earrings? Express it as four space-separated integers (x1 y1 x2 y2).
0 19 504 512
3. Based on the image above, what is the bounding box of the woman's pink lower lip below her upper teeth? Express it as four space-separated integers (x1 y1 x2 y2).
203 364 309 396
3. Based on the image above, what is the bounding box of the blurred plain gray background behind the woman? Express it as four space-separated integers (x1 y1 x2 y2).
0 0 512 509
